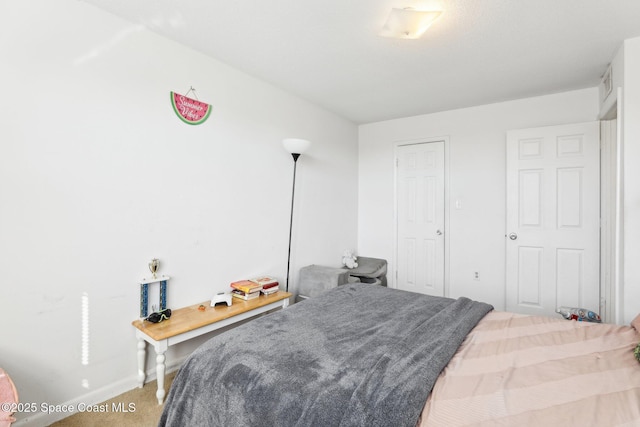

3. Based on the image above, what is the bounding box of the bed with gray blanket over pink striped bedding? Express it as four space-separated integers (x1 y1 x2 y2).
159 283 640 427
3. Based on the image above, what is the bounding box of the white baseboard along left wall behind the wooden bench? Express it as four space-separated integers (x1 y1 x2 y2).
12 355 188 427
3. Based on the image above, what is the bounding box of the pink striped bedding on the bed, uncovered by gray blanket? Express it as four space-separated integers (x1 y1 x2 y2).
418 311 640 427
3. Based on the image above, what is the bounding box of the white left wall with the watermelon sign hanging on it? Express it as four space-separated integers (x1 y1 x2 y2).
0 0 358 425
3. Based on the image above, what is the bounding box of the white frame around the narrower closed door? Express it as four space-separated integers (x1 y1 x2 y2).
387 136 450 297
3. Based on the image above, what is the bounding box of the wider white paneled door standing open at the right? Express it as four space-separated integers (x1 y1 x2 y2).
505 122 600 316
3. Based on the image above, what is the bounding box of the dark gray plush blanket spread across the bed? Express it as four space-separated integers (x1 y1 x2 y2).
160 283 492 427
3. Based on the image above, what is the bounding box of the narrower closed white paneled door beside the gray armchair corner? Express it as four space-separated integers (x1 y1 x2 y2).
396 141 444 296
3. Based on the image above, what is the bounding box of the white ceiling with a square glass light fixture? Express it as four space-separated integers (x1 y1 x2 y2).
82 0 640 123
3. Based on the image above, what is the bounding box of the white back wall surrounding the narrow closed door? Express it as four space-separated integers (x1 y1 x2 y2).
358 88 599 310
